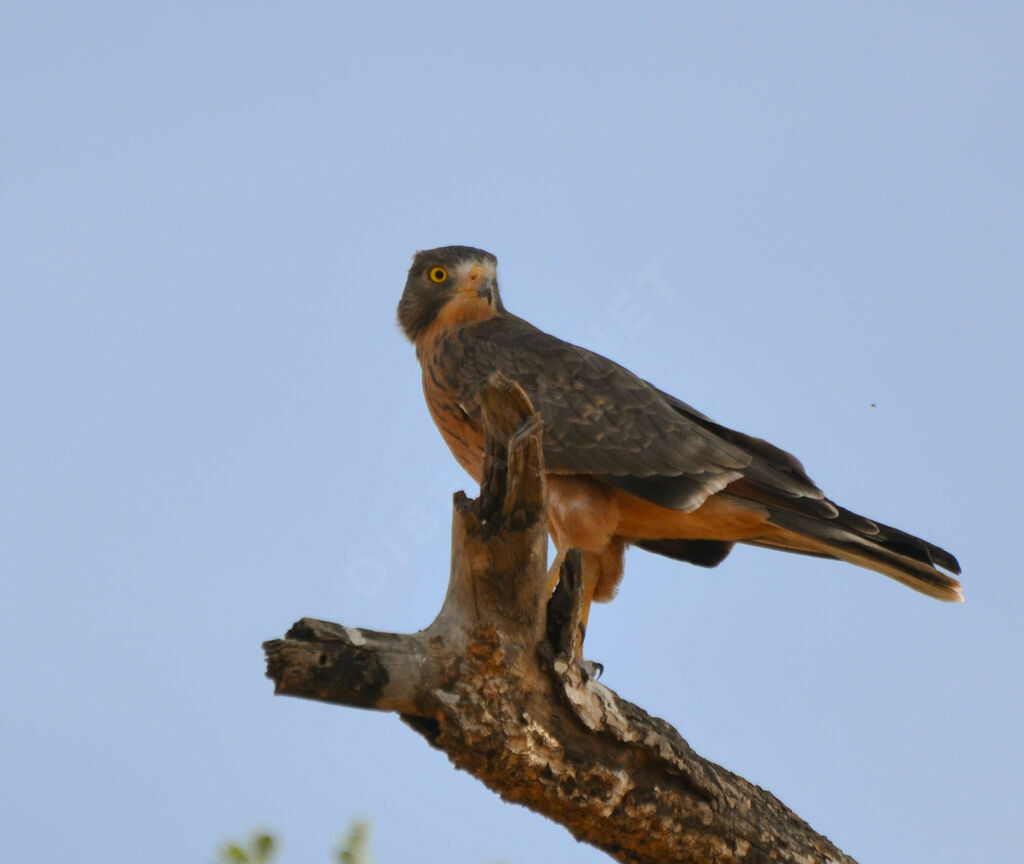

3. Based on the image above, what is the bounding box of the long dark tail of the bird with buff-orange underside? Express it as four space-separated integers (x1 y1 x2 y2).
745 505 964 603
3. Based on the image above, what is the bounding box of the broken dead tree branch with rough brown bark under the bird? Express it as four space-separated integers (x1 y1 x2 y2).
263 376 853 864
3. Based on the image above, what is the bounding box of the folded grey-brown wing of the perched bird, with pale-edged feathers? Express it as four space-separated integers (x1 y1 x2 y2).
442 315 752 511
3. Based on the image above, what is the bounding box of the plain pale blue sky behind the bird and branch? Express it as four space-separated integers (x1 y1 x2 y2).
0 2 1024 864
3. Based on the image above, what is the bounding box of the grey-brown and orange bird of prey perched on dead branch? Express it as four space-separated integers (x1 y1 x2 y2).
398 246 963 622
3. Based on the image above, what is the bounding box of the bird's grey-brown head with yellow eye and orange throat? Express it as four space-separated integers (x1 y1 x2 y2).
398 246 505 342
